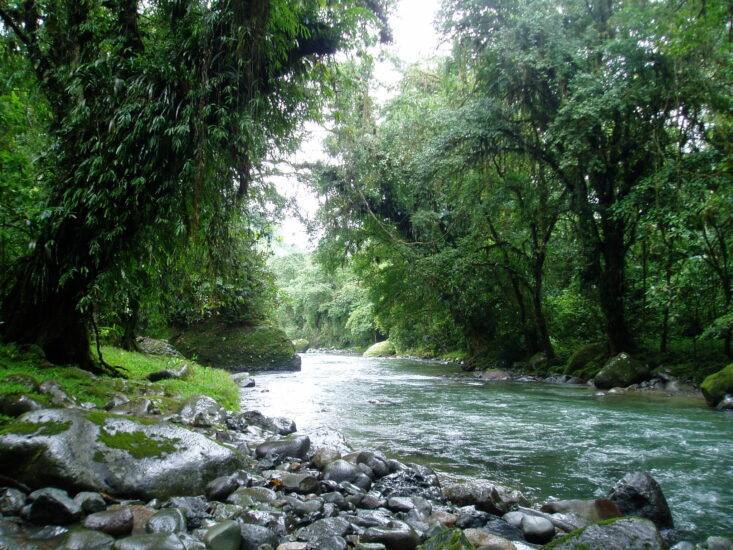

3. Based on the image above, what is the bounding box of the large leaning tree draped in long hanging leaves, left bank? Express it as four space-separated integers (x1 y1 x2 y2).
0 0 383 376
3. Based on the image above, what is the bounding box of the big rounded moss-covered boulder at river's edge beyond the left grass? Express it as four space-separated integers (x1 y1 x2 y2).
173 320 300 372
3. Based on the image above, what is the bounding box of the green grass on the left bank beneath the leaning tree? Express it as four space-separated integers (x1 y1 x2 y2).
0 344 239 425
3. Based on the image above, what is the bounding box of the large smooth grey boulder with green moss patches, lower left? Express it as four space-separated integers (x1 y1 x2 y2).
0 409 246 500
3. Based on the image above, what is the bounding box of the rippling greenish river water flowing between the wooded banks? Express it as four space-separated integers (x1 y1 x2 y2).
243 353 733 538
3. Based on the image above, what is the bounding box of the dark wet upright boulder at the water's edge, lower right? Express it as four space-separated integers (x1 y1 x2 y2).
608 472 674 529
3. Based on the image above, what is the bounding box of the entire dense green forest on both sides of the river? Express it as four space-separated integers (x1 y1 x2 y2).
0 0 733 379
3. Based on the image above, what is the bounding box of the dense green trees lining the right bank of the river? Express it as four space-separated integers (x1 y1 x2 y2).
314 0 733 366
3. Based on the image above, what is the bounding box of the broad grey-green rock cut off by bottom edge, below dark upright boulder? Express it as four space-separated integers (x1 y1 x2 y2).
543 517 667 550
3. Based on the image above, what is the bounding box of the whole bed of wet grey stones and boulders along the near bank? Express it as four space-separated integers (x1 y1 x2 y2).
0 375 733 550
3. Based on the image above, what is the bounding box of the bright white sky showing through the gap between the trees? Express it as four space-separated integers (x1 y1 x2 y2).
276 0 440 249
